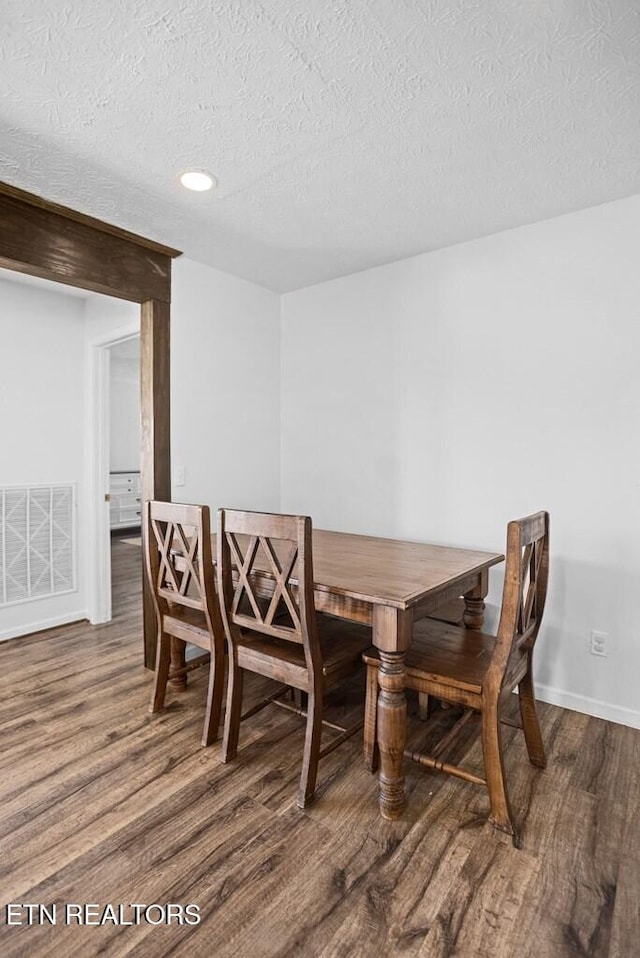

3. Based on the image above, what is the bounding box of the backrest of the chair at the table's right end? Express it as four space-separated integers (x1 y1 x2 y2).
487 512 549 685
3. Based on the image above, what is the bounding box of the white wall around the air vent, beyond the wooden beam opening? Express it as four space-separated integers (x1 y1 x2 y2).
0 280 86 638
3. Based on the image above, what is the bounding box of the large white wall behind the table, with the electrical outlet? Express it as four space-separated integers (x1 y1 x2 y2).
282 197 640 726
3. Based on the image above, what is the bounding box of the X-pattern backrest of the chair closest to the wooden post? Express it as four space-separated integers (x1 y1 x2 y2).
145 500 222 638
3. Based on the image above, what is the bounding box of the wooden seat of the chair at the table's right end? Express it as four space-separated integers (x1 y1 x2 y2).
364 619 496 693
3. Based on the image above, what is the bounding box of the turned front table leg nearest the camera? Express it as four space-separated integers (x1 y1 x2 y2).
373 606 413 819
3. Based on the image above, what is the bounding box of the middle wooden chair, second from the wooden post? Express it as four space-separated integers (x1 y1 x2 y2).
217 509 371 808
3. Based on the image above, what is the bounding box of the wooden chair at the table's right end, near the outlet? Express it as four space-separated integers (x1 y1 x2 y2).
364 512 549 847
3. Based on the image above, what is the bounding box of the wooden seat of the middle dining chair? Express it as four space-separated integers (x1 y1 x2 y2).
238 614 371 691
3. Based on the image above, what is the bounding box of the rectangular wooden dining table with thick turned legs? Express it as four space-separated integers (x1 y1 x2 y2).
175 529 504 819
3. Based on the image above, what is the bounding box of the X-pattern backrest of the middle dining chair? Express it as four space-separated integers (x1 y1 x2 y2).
217 509 321 667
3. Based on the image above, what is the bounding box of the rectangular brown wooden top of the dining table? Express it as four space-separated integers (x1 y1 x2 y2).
212 529 504 609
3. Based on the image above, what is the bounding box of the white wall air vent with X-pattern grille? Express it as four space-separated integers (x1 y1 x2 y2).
0 485 75 605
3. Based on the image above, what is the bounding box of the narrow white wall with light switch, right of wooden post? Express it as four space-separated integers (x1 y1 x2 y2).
171 257 280 522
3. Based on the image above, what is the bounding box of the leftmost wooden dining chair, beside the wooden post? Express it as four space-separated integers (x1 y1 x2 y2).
145 501 225 746
